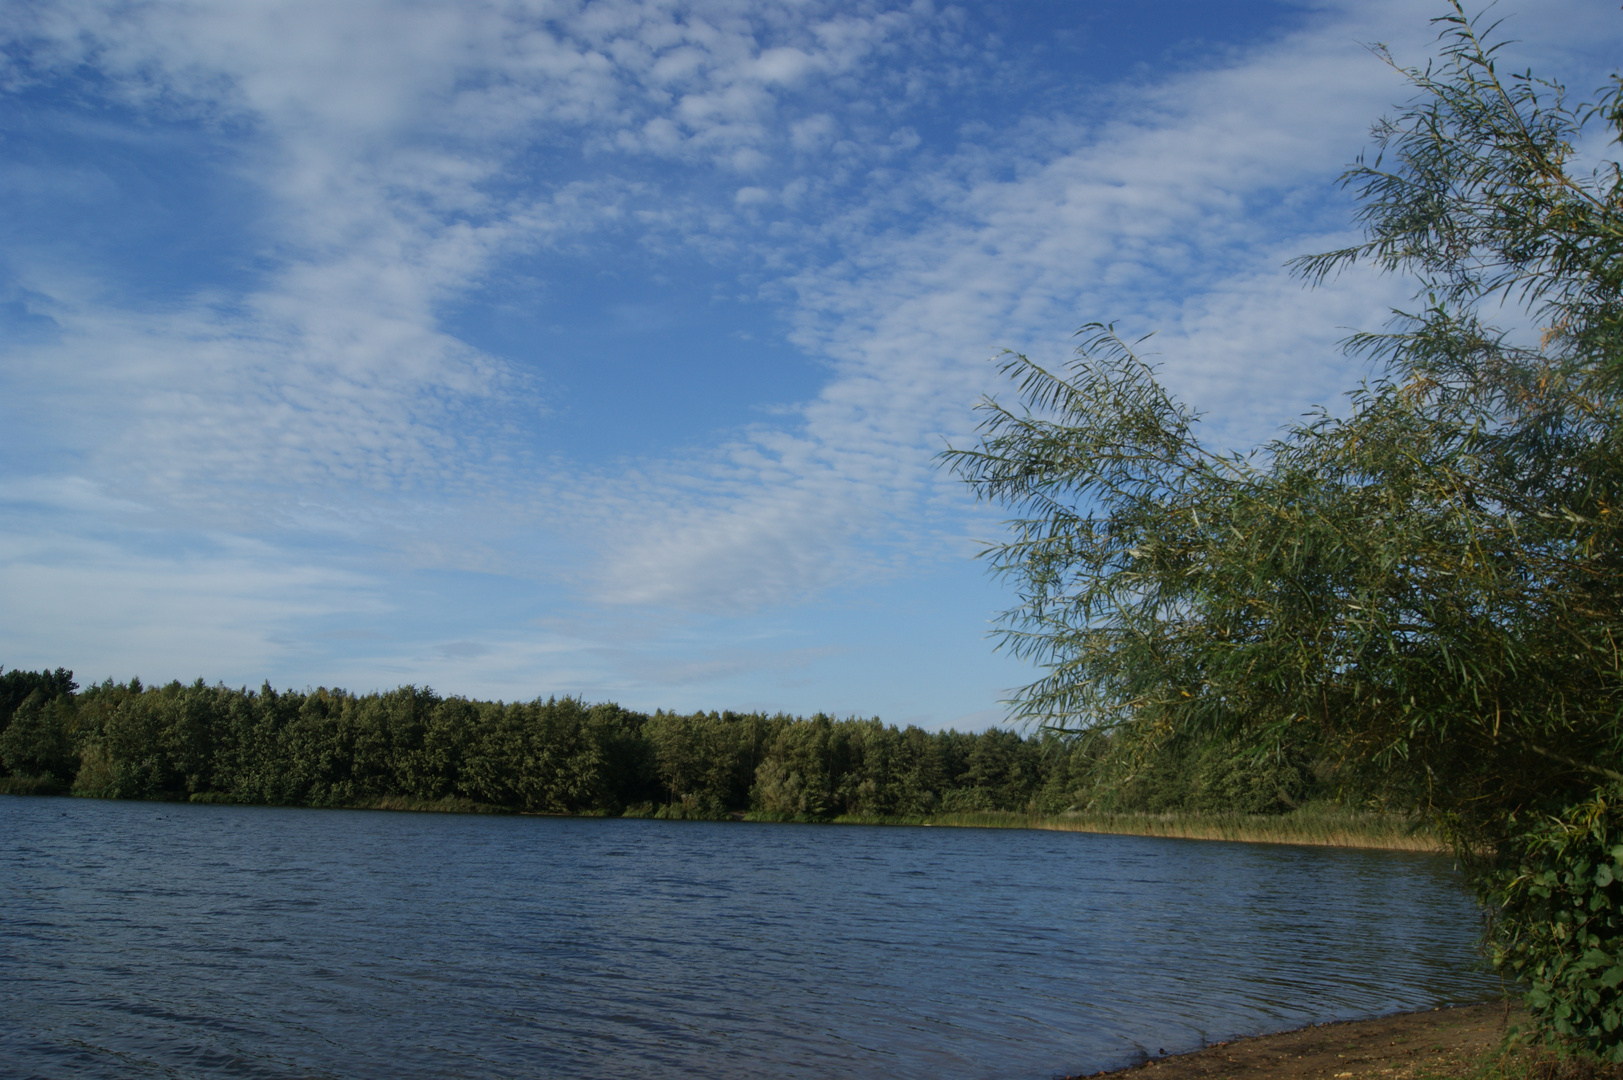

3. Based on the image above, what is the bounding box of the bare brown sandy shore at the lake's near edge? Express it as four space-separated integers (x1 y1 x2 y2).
1066 1002 1526 1080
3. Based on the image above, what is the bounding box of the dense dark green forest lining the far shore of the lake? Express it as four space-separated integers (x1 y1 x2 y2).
0 667 1332 822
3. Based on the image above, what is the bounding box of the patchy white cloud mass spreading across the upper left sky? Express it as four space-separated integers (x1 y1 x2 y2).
0 0 954 521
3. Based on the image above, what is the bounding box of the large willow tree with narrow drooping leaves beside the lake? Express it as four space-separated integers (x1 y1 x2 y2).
945 5 1623 1061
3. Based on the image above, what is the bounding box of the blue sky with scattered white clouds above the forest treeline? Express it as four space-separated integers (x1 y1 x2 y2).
0 0 1623 729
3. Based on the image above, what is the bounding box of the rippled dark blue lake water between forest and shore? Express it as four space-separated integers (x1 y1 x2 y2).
0 796 1498 1080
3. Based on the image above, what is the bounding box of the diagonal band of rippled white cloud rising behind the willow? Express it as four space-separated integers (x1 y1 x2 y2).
574 0 1434 611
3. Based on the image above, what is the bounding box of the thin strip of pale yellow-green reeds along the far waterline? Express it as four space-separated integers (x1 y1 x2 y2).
834 806 1446 851
